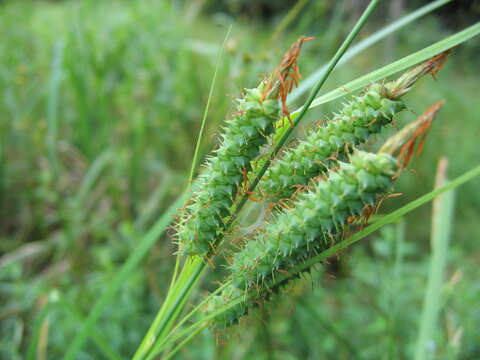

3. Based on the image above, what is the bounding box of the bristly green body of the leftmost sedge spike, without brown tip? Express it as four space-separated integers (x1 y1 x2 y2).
177 83 281 255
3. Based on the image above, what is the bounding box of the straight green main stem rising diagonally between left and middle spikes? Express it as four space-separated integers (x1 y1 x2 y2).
133 0 380 360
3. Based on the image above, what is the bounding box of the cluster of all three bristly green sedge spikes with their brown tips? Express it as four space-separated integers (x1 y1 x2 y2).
177 48 446 328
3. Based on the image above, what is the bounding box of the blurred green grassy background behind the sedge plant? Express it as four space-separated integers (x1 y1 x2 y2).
0 0 480 359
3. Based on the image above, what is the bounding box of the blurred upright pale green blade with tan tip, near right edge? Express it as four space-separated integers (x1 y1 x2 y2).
415 159 455 360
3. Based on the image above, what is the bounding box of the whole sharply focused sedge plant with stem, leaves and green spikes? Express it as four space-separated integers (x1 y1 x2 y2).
59 0 480 359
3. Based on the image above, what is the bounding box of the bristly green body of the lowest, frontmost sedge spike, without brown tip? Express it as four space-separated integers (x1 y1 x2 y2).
209 151 398 327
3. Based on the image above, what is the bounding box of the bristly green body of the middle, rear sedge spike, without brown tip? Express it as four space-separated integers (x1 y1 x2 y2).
260 84 405 203
